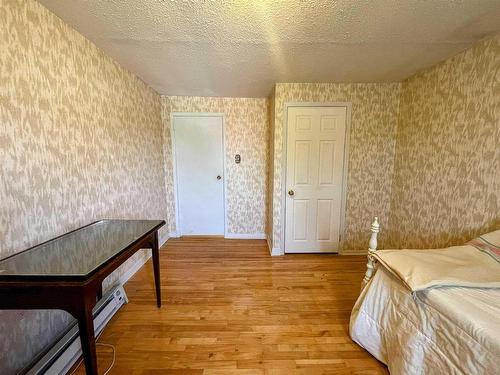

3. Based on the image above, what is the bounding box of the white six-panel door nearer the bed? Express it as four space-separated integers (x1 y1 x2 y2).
285 107 347 253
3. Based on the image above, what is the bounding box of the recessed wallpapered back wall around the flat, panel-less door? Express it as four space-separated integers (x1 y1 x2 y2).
162 96 269 235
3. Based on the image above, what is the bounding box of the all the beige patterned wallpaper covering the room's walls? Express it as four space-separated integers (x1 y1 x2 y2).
0 0 500 374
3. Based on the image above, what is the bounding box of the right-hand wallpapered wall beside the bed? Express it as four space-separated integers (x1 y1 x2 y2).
389 35 500 248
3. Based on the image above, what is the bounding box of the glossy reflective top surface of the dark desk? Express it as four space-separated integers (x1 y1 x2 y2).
0 220 165 280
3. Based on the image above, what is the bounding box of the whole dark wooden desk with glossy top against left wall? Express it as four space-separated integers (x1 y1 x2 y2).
0 220 165 375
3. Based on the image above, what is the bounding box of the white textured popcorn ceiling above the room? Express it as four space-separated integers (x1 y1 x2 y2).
40 0 500 97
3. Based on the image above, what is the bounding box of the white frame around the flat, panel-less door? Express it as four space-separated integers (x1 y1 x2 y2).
170 112 228 237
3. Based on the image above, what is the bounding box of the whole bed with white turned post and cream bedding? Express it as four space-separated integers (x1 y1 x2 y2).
350 218 500 375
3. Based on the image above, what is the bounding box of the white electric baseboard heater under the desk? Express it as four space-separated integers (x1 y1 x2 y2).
26 286 128 375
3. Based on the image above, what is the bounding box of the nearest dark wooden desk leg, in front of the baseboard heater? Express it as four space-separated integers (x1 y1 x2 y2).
77 296 97 375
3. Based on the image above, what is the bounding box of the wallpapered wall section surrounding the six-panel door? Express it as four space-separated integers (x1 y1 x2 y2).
272 83 400 251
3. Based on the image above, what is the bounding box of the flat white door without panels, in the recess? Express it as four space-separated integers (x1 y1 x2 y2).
173 114 224 235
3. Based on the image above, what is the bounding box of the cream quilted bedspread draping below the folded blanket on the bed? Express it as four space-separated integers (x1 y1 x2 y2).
350 266 500 375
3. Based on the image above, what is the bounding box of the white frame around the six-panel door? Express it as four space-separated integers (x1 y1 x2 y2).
280 102 352 255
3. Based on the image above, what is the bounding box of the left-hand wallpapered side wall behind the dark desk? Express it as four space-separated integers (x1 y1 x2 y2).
0 0 167 374
